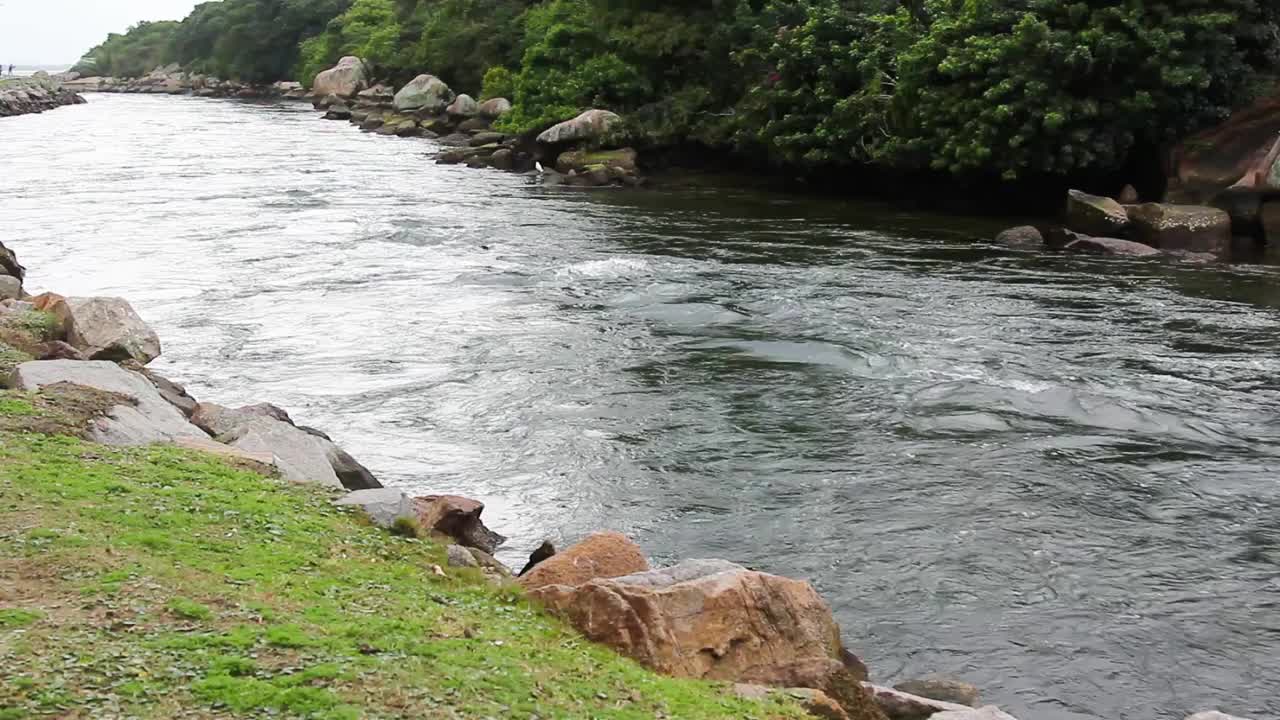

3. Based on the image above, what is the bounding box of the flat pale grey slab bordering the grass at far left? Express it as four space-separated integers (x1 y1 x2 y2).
12 360 209 446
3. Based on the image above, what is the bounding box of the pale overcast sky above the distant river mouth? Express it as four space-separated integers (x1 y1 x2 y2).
0 0 197 65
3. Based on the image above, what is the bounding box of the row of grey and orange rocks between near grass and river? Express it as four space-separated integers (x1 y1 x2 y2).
0 229 1259 720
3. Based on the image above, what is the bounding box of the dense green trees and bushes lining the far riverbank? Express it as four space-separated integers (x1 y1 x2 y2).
72 0 1280 188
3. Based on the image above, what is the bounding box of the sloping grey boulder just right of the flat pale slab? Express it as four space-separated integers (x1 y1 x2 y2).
191 402 343 488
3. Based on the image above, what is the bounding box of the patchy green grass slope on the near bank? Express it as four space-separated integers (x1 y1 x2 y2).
0 392 803 720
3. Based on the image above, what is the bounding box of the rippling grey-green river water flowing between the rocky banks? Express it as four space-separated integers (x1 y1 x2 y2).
0 96 1280 720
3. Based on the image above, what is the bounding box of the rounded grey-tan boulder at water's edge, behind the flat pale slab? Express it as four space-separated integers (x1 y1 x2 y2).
49 297 160 365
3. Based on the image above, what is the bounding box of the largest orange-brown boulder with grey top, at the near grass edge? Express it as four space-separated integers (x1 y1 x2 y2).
529 552 863 686
